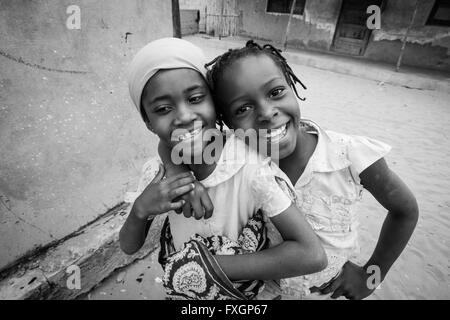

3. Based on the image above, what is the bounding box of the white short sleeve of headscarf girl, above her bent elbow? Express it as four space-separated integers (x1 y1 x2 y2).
251 163 293 218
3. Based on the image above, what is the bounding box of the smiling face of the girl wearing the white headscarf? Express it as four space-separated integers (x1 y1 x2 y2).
141 69 216 156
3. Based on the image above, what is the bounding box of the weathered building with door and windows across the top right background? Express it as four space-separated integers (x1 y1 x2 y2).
180 0 450 71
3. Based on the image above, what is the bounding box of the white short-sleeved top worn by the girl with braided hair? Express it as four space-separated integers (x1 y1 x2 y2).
282 121 391 298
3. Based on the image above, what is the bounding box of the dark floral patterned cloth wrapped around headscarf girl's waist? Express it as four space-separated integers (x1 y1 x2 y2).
159 211 268 300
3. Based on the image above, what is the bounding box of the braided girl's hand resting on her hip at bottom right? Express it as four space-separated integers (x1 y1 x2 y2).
311 261 375 300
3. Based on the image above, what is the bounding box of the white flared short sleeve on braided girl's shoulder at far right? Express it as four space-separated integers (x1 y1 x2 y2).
347 136 392 181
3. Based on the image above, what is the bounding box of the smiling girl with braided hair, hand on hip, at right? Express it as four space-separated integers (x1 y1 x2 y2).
164 41 418 299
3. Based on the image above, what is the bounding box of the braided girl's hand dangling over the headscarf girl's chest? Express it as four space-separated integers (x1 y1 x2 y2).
175 180 214 220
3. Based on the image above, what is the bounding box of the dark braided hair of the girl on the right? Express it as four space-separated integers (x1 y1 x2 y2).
205 40 306 129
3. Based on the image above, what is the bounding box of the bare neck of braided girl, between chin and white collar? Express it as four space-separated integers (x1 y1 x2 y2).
280 128 317 185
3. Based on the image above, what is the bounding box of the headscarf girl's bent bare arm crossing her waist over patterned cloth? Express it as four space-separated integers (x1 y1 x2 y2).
216 205 327 280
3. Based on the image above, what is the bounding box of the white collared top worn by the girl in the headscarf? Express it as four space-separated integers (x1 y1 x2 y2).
127 135 294 249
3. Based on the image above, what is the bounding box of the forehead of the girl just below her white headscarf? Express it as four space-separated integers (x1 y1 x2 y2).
142 68 206 98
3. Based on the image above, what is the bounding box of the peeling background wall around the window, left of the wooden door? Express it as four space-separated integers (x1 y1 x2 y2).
238 0 342 50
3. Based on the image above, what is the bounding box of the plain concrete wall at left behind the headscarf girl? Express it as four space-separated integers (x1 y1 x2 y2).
0 0 173 270
